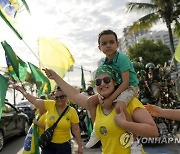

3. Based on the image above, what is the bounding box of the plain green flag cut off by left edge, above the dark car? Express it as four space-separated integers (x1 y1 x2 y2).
0 74 8 119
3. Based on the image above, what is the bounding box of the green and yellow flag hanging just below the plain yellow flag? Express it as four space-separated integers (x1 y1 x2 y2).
28 62 51 97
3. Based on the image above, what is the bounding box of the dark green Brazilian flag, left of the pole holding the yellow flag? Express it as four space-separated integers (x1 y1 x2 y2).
1 41 27 81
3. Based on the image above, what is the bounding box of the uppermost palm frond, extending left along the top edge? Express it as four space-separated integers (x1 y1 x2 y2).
127 2 157 12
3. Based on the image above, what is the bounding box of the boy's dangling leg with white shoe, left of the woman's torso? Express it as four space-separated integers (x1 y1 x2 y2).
85 95 99 148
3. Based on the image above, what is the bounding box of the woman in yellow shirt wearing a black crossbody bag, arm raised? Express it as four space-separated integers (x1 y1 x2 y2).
13 84 83 154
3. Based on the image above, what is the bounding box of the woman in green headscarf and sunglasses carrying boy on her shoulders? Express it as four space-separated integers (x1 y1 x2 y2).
44 66 158 154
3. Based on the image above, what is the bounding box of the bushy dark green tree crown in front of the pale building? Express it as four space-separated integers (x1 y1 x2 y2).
127 39 171 65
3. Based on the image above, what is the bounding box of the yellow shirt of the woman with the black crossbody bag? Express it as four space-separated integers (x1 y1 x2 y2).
45 100 79 143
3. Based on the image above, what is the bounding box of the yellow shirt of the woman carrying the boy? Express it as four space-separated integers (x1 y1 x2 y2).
94 98 144 154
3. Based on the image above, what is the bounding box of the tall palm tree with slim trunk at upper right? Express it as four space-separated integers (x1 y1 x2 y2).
127 0 180 68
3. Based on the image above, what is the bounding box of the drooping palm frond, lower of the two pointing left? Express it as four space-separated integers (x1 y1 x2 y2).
128 13 159 34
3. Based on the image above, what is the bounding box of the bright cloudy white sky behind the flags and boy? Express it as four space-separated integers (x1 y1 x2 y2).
0 0 167 89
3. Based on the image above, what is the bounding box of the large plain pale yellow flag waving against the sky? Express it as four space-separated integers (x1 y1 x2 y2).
39 38 74 87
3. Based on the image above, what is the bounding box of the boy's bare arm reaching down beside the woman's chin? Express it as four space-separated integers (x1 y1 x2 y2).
104 70 129 108
